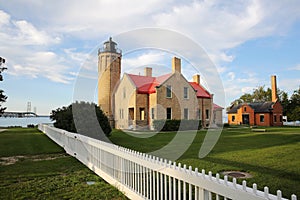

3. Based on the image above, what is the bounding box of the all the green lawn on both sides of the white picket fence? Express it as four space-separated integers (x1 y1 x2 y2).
0 127 300 199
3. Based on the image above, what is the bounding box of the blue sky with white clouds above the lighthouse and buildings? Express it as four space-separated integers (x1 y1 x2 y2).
0 0 300 115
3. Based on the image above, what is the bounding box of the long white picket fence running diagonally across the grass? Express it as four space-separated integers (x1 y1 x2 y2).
39 124 297 200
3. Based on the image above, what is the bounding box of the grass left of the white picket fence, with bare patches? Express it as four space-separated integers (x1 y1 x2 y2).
0 128 126 199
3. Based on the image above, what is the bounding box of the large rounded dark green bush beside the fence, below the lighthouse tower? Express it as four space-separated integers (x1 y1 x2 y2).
50 102 112 141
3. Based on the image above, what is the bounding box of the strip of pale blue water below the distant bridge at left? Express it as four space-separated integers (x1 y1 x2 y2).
0 117 53 127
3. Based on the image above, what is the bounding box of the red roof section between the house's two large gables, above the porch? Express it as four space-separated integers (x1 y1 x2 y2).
128 74 172 94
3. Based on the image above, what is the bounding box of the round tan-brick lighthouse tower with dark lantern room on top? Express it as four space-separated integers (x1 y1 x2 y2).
98 37 122 127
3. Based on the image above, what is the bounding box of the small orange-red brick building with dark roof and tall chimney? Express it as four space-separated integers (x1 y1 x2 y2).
227 76 283 126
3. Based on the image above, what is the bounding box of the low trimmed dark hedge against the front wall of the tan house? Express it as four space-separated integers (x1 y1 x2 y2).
153 119 202 131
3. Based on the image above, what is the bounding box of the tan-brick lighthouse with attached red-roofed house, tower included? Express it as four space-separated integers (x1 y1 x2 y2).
98 38 222 129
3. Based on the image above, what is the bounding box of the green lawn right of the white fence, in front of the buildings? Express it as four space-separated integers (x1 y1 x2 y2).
110 127 300 198
